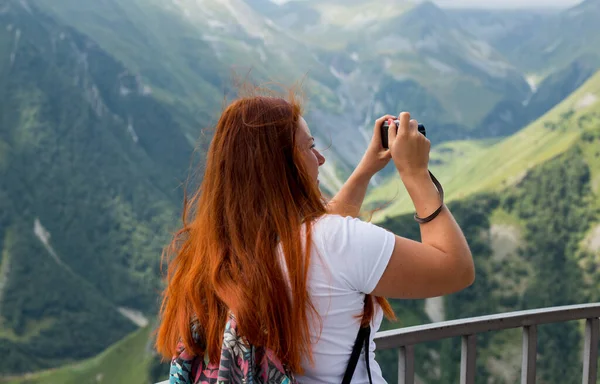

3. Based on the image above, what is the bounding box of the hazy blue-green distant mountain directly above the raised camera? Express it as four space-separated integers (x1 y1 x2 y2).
255 0 531 143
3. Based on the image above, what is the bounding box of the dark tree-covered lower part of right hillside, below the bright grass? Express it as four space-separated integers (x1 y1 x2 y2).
378 121 600 384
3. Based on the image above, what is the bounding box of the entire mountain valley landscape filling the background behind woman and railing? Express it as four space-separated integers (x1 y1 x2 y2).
0 0 600 384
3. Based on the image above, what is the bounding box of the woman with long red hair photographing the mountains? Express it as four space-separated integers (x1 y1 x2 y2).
157 88 474 383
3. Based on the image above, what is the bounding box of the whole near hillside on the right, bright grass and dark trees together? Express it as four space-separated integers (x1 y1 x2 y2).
370 72 600 384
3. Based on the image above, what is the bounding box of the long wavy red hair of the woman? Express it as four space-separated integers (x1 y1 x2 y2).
156 85 393 373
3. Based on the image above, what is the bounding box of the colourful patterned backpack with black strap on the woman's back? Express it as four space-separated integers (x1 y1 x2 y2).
169 314 372 384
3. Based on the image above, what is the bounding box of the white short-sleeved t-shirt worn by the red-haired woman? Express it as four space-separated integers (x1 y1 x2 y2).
297 215 395 384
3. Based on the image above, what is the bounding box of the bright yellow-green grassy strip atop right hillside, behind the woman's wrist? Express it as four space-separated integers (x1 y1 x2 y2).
366 67 600 221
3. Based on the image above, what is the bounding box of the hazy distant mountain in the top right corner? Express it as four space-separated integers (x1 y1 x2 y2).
447 0 600 140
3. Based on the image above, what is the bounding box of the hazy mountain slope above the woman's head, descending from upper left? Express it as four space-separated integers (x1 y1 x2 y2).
34 0 335 130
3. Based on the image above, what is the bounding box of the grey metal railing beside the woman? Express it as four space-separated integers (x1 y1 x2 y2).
157 303 600 384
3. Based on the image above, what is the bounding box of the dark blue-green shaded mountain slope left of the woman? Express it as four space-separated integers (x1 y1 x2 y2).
0 1 193 374
